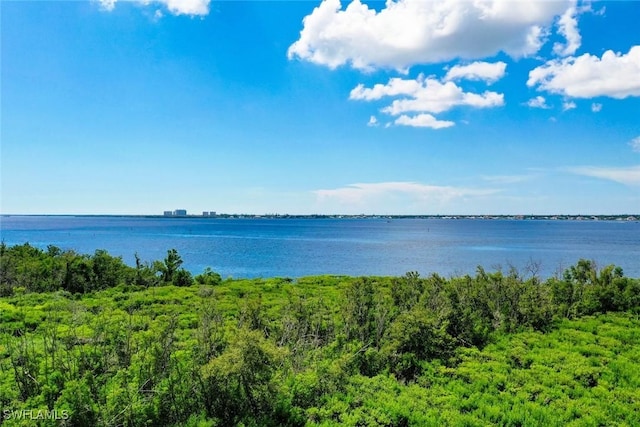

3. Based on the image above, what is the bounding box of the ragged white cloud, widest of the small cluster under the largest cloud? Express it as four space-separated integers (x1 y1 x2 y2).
349 75 504 116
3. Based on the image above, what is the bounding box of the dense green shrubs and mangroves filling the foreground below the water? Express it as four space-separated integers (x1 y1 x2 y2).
0 244 640 426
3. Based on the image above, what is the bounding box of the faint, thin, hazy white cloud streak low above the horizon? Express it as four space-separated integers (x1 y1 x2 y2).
314 182 500 210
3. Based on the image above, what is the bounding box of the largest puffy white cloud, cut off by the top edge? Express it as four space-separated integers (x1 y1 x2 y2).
288 0 577 71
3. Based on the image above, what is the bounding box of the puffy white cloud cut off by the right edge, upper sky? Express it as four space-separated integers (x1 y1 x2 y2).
527 46 640 99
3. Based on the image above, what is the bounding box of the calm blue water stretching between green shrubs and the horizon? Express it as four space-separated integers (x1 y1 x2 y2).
0 216 640 277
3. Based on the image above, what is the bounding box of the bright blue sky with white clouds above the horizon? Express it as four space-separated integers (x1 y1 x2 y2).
0 0 640 214
